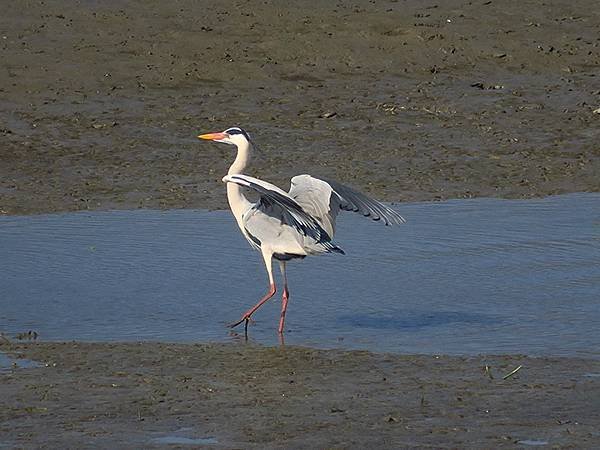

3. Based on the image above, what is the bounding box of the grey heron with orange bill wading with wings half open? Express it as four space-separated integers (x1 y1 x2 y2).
198 127 404 335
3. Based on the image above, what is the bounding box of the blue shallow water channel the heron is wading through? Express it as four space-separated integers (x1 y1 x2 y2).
0 194 600 357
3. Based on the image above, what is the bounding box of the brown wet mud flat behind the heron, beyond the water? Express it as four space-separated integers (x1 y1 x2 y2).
0 0 600 214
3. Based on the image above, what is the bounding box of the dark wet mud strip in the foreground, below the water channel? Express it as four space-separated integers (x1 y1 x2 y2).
0 342 600 448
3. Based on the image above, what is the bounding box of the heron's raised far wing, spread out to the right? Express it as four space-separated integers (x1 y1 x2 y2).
289 175 405 235
